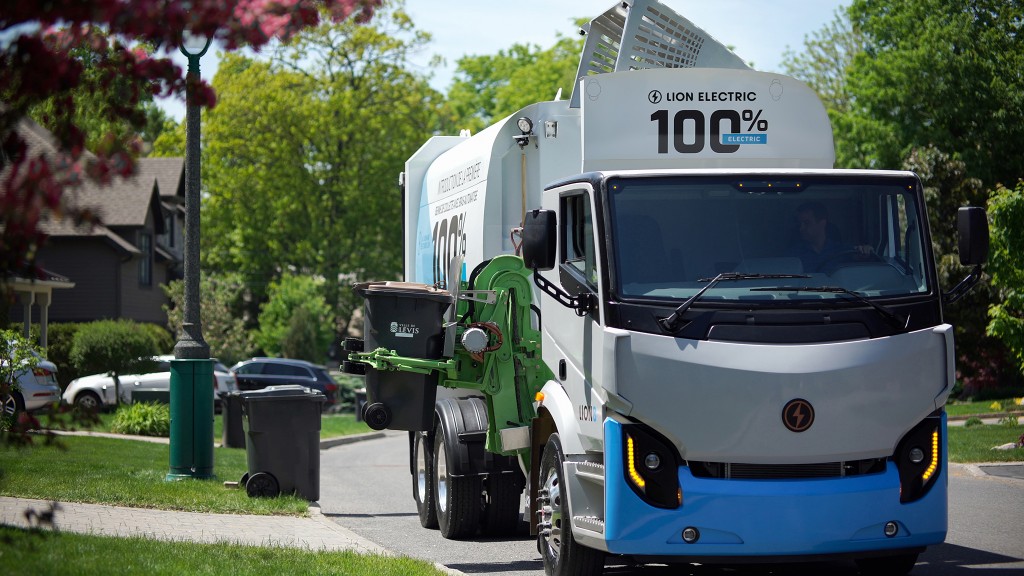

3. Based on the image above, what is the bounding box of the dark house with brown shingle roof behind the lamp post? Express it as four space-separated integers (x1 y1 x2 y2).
10 119 184 340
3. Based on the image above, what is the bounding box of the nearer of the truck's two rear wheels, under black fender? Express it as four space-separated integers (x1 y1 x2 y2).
432 425 481 540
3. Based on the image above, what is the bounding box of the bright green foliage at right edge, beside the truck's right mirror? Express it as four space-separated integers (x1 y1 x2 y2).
988 180 1024 373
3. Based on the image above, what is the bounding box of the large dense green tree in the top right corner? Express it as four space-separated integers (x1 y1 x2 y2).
848 0 1024 187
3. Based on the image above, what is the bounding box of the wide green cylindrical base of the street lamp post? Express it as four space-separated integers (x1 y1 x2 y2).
167 359 213 480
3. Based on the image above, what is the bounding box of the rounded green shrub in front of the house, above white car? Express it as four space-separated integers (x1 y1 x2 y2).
70 320 160 403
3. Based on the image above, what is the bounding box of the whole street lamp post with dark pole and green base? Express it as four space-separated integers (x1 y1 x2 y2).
167 32 213 480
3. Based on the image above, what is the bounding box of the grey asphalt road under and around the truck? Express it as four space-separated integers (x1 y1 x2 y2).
319 433 1024 576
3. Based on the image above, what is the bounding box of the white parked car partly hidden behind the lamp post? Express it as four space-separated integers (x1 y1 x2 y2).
61 355 239 410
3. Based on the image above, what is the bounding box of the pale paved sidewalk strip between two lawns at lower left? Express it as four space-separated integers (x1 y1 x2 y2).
0 497 388 554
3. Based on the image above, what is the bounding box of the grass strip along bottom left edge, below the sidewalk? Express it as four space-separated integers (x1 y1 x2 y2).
0 526 441 576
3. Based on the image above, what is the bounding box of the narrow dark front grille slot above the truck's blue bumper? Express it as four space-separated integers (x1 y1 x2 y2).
689 458 886 480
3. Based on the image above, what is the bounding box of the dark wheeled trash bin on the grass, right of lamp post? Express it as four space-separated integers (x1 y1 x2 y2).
240 384 327 501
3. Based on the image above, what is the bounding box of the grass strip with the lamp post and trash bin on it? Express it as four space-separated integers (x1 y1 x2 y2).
0 437 308 510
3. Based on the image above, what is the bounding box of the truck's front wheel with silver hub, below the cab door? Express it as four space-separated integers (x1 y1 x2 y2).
537 434 604 576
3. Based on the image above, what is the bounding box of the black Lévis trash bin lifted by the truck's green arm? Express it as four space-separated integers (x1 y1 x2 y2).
354 282 452 430
